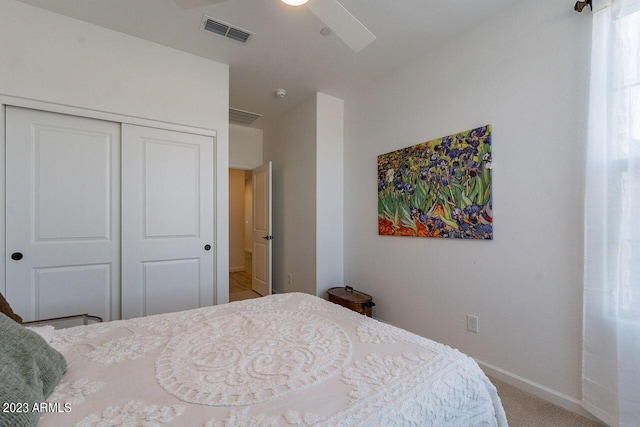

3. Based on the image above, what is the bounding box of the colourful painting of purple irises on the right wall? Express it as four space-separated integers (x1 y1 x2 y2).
378 125 493 239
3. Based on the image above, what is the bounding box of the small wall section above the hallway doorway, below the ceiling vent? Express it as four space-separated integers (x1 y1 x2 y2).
229 124 263 169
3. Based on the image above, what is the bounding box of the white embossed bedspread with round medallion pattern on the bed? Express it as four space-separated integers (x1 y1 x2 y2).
39 293 507 427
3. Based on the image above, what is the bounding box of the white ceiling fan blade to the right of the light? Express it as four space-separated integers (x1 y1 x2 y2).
308 0 376 53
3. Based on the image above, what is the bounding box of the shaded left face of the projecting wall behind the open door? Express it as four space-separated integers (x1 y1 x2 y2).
264 96 317 295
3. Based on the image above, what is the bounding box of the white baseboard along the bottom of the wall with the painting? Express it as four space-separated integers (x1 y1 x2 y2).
475 359 602 423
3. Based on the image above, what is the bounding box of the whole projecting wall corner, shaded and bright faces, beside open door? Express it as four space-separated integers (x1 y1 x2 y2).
264 93 344 297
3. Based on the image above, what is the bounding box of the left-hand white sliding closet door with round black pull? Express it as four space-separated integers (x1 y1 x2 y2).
6 107 120 320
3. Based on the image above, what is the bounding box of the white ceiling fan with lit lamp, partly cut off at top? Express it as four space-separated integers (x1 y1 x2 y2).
174 0 376 53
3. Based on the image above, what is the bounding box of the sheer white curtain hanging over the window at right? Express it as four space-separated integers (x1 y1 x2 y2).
582 0 640 427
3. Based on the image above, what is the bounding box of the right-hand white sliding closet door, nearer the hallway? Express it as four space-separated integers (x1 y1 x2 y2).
122 125 215 319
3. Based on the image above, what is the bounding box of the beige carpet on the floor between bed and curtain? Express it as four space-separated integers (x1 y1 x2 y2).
491 378 602 427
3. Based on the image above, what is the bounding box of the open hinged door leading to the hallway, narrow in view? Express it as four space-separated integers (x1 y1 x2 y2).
251 162 273 296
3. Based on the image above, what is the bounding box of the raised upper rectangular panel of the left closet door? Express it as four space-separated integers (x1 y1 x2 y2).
32 132 111 242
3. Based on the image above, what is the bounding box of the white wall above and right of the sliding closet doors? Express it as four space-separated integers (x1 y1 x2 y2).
0 0 229 302
